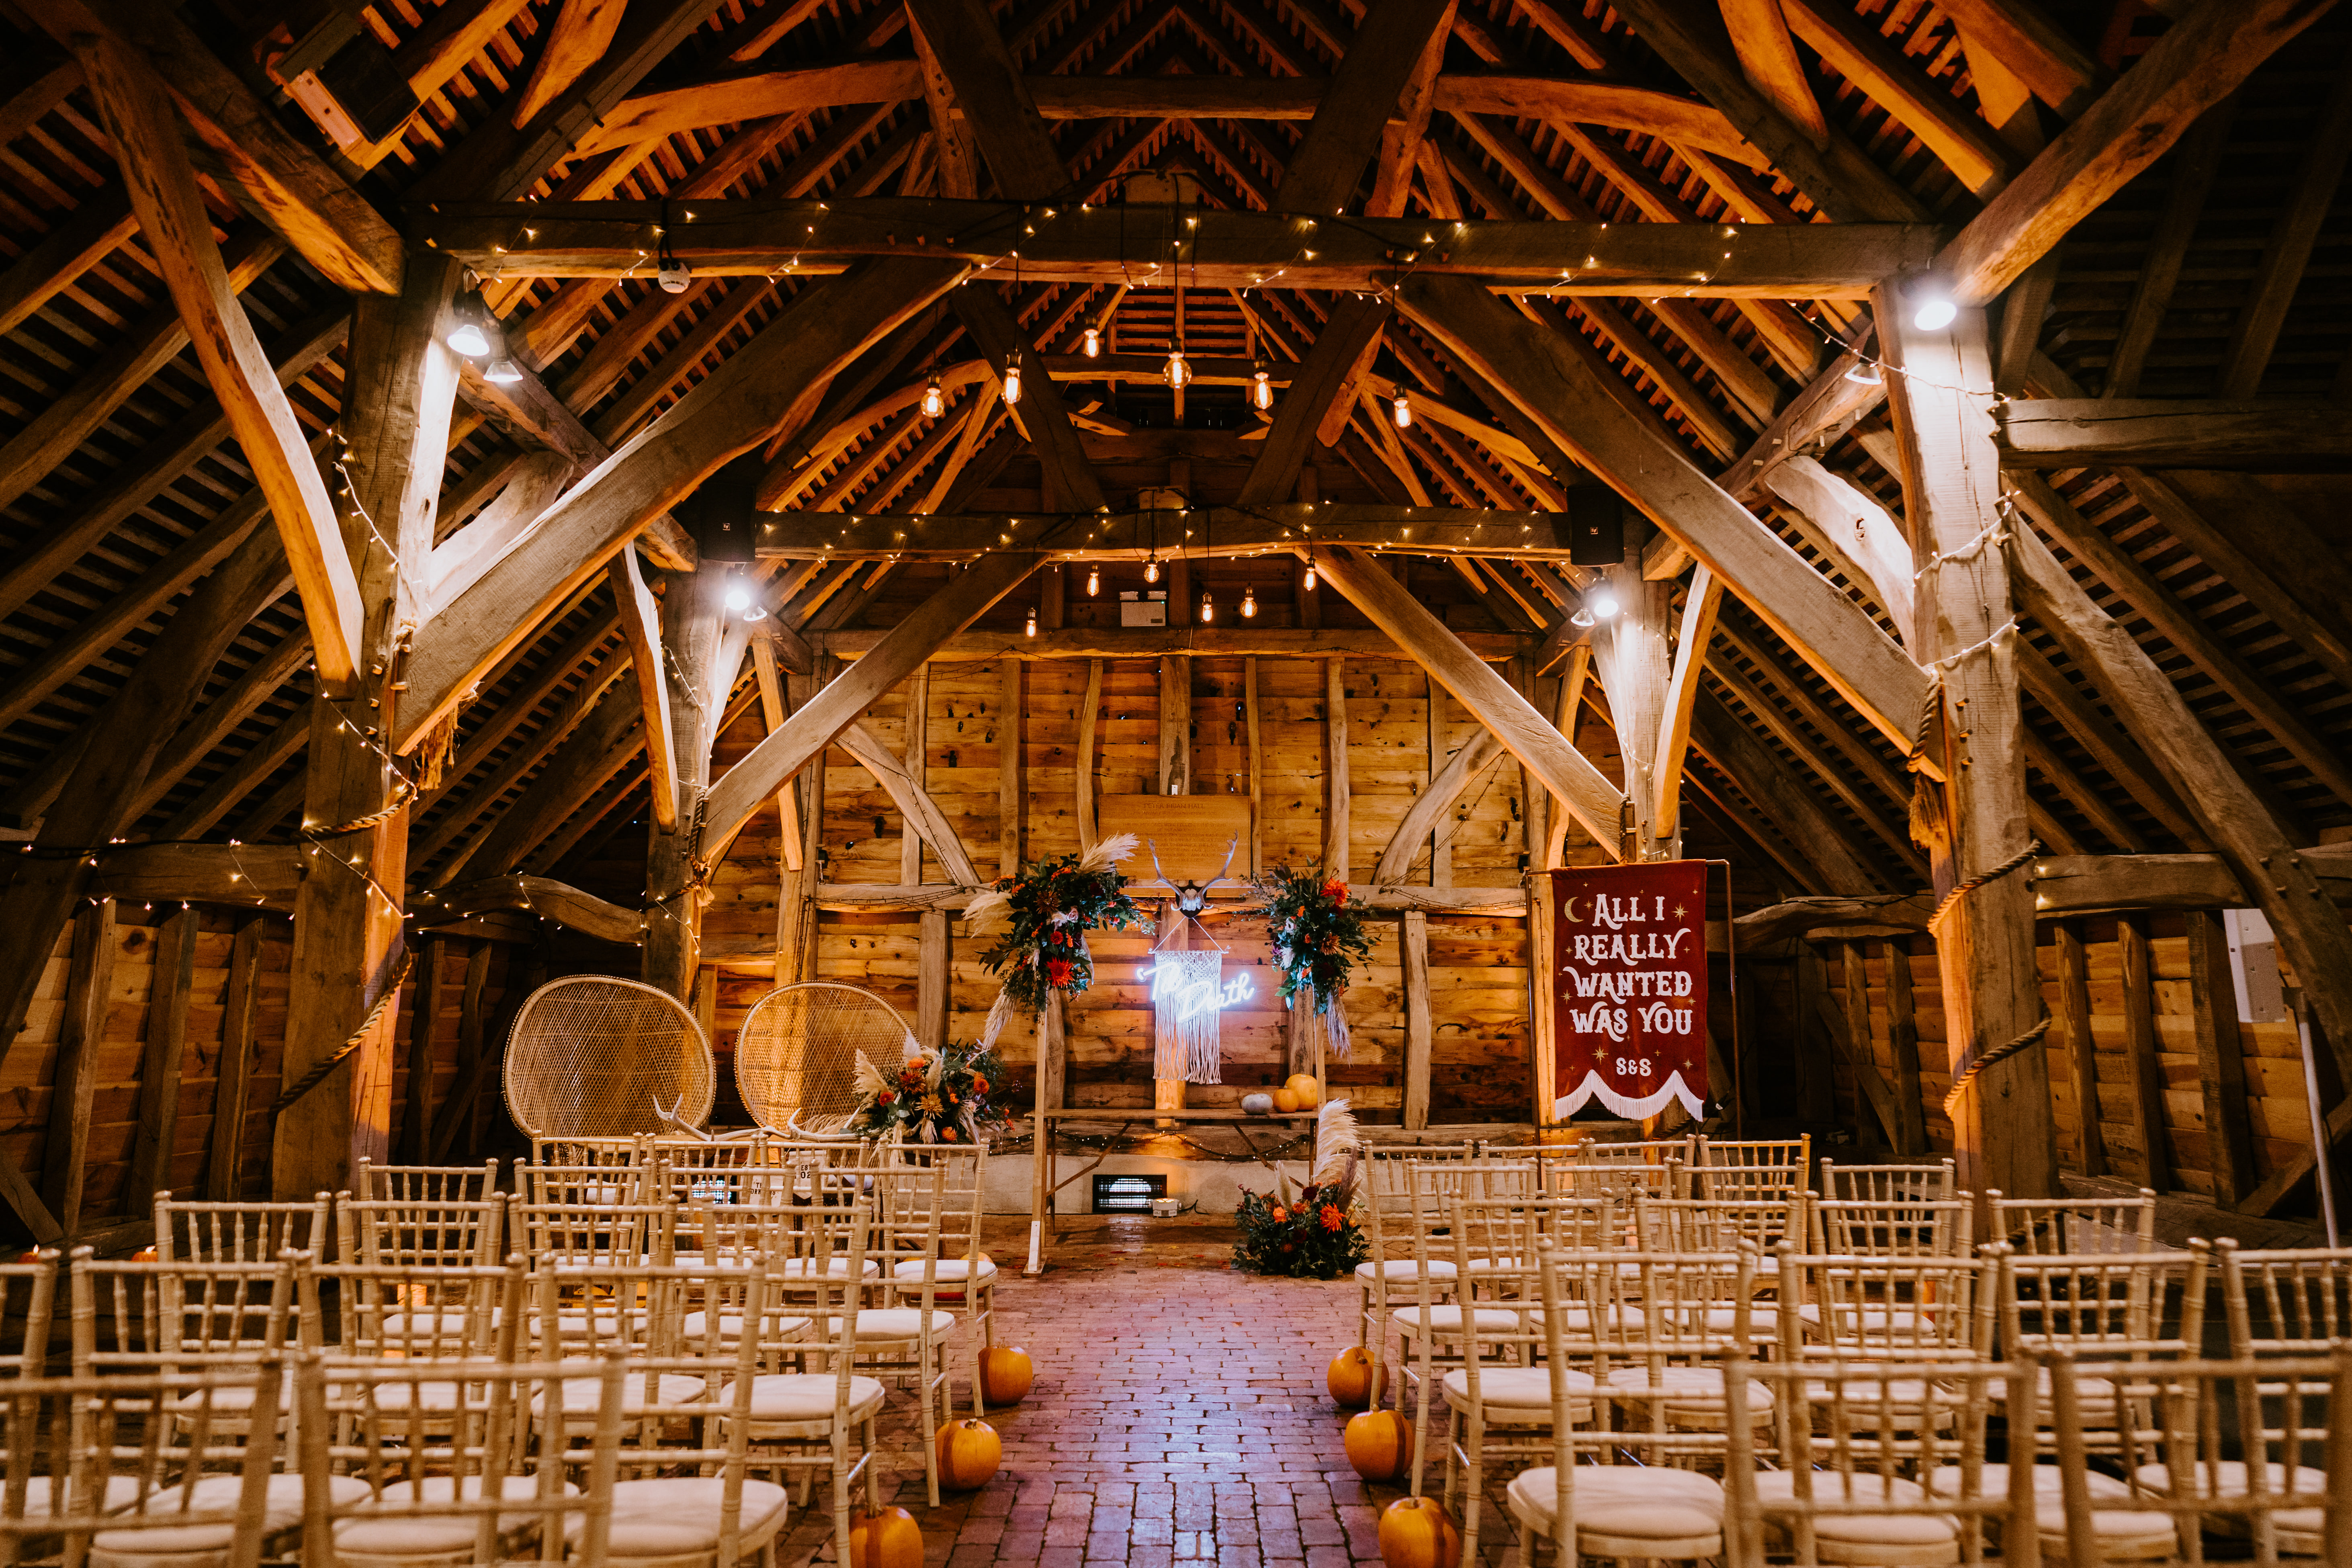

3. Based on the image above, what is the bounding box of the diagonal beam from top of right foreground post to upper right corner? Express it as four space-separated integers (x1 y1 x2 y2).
1928 0 2333 306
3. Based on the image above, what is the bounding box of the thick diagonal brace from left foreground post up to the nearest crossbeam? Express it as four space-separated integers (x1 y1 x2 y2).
393 261 962 750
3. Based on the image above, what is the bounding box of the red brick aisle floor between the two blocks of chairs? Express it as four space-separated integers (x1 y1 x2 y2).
778 1220 1508 1568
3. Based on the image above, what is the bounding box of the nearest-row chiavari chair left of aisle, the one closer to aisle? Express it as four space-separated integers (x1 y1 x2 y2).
294 1354 628 1568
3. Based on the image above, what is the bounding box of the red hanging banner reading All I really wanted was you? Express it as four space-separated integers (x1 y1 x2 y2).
1550 860 1707 1119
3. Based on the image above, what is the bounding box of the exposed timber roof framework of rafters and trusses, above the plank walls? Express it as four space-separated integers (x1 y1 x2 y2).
0 0 2352 1192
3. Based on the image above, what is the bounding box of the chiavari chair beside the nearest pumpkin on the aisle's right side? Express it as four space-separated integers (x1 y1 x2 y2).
1416 1199 1607 1563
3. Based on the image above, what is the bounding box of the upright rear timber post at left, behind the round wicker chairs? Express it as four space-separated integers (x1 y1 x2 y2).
644 571 724 999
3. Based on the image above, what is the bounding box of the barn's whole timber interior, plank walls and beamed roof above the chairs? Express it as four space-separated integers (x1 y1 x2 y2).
0 0 2352 1253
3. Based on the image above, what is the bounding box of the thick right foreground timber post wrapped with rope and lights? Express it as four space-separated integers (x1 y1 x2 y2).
1877 287 2058 1197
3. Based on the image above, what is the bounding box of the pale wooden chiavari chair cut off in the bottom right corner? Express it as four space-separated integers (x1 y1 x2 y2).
2070 1345 2352 1566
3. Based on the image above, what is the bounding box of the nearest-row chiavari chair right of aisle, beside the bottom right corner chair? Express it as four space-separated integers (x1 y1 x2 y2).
1724 1361 2056 1568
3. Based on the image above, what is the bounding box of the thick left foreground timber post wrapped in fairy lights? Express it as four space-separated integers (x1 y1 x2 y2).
270 261 459 1199
